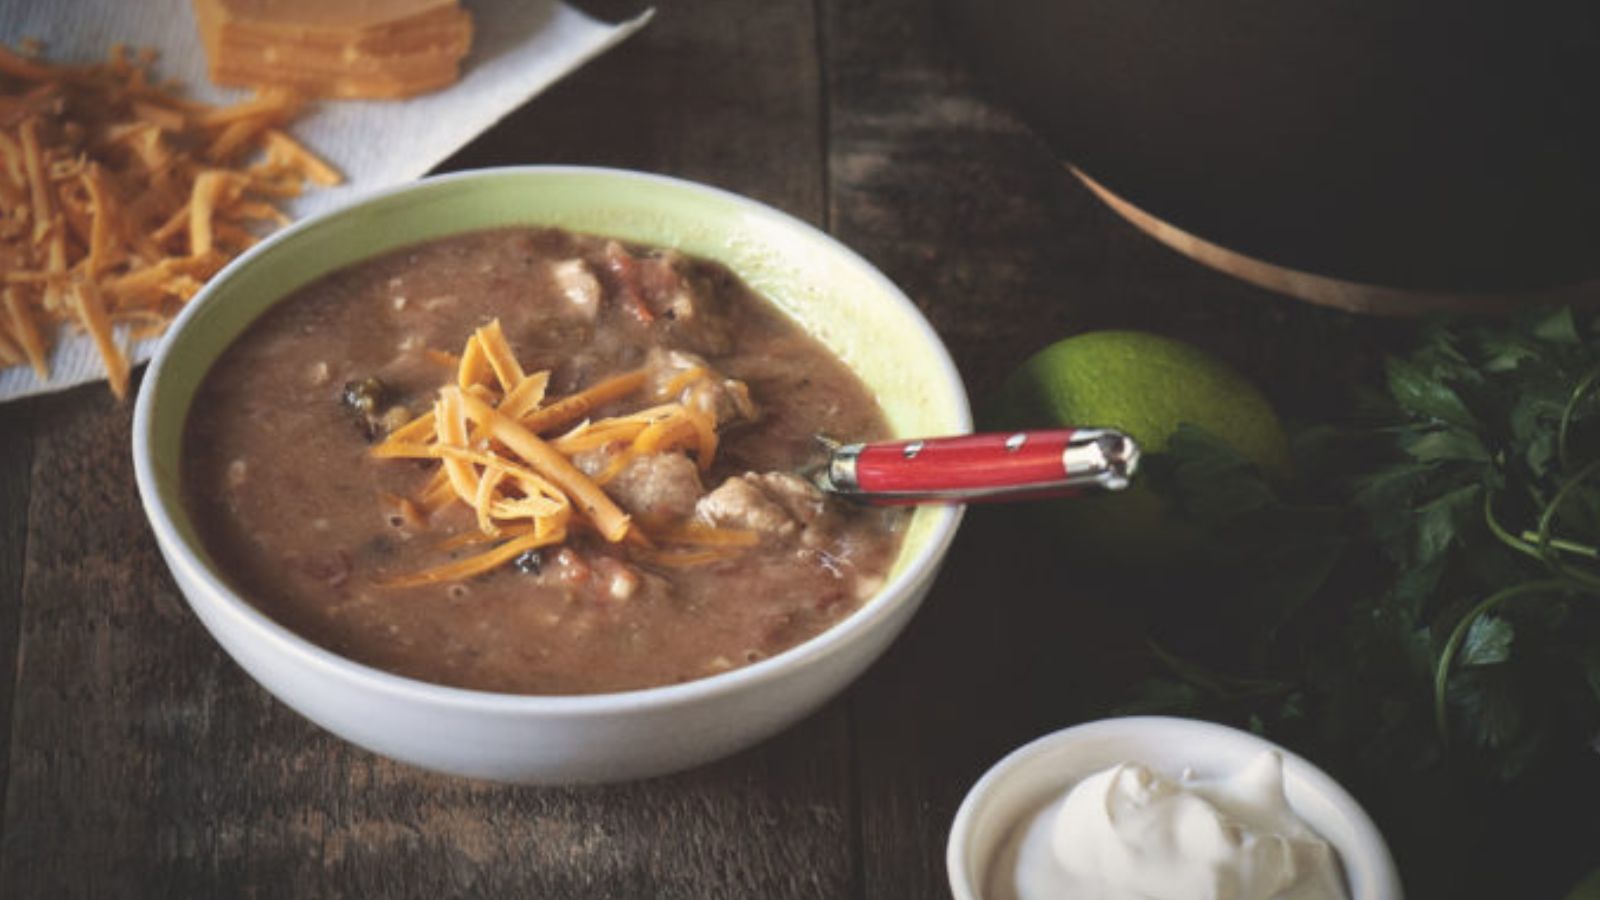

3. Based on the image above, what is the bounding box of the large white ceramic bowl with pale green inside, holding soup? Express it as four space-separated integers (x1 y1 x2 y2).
133 167 971 783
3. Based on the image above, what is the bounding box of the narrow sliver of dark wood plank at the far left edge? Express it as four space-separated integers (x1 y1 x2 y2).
0 400 38 834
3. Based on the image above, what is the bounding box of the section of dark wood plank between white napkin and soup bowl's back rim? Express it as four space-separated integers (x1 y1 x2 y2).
440 0 822 223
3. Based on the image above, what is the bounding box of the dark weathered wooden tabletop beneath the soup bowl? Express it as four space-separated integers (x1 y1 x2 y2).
0 0 1440 900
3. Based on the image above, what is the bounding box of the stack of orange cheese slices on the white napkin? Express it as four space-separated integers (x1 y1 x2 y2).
194 0 472 99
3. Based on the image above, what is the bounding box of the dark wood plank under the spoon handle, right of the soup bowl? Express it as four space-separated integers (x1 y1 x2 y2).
822 0 1408 898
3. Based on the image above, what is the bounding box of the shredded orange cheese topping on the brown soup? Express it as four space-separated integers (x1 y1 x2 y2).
371 319 758 588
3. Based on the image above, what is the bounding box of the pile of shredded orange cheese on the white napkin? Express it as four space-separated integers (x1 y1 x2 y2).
0 45 341 397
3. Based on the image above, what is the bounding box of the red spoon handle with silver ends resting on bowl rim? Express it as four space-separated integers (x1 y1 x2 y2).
814 428 1139 506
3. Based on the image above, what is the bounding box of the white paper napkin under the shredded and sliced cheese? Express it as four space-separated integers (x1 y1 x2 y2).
0 0 653 402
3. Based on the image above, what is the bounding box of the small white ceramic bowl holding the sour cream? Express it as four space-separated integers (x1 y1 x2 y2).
946 716 1402 900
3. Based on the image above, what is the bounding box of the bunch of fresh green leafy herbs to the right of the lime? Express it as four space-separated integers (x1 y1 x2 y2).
1123 311 1600 884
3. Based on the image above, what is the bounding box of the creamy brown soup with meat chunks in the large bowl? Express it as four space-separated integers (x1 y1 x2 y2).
184 229 902 693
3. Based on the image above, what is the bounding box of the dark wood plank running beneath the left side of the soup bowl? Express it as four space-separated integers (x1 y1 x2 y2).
0 0 856 900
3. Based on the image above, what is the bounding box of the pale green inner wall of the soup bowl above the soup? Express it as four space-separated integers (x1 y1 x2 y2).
150 170 970 582
